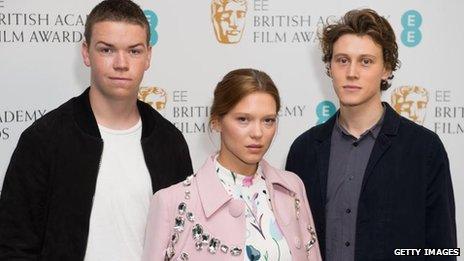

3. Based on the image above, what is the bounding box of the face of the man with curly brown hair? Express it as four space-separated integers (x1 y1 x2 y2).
330 34 390 108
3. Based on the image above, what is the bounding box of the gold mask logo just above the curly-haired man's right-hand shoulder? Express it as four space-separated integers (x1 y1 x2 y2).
391 86 429 125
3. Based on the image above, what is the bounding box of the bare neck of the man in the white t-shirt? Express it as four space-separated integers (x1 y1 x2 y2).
89 87 140 130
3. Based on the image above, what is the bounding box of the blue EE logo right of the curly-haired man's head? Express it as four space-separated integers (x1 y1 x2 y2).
401 10 422 47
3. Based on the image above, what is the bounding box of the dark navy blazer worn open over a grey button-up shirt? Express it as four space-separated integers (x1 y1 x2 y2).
286 103 457 260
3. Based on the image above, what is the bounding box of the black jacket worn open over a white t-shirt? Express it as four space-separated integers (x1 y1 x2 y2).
0 89 192 261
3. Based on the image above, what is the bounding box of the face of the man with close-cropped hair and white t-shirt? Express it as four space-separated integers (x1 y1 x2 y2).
82 21 151 100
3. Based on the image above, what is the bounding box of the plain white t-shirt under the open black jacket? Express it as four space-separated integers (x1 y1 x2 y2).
84 120 153 261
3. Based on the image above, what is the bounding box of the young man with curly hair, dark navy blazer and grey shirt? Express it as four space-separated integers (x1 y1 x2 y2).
286 9 456 261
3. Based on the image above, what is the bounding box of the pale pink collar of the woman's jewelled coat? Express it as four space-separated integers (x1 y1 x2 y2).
195 155 295 218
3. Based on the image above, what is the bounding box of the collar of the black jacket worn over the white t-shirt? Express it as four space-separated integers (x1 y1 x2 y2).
73 87 161 139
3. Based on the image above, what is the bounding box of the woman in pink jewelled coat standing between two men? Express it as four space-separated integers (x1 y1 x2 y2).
143 69 321 261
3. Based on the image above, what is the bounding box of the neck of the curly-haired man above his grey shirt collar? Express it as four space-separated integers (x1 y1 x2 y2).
339 100 384 138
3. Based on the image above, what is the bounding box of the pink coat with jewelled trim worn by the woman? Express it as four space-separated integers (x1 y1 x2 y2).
142 156 321 261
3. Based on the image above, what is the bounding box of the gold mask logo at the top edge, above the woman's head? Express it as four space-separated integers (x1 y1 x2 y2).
211 0 247 44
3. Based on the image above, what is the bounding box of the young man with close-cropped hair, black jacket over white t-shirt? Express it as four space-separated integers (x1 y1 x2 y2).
0 0 192 261
